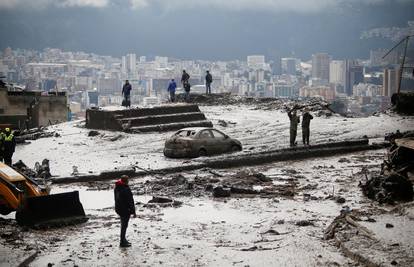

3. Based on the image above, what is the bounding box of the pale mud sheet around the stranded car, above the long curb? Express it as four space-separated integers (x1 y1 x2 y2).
14 105 414 176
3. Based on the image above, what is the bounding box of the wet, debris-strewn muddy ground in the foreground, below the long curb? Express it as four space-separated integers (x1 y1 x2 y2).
0 150 414 266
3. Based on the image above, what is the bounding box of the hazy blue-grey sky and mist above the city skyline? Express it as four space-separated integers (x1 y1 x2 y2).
0 0 414 60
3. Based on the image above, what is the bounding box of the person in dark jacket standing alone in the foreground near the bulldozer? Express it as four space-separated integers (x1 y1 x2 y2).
114 175 137 247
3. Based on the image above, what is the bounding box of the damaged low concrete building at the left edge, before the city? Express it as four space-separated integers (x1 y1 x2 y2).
0 87 69 129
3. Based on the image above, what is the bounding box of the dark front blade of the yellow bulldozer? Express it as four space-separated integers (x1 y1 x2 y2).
16 191 88 228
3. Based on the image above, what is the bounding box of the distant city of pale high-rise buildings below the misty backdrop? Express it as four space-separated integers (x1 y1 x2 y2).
0 47 414 116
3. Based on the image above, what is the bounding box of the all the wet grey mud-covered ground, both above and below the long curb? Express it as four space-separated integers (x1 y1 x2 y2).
0 104 414 266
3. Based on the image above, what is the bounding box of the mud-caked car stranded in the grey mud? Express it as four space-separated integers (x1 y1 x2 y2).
164 127 242 158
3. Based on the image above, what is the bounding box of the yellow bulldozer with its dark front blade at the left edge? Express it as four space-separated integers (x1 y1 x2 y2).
0 162 88 227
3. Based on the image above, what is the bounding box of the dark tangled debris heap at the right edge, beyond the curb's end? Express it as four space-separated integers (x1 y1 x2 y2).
360 131 414 204
